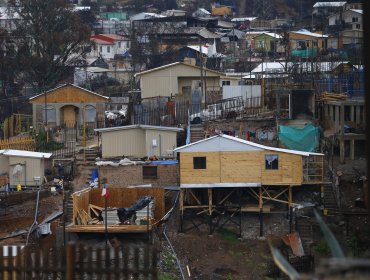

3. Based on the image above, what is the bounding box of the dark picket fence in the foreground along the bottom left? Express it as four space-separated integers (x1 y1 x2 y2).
0 244 158 280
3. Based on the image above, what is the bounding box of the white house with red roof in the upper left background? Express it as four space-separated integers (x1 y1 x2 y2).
88 34 130 60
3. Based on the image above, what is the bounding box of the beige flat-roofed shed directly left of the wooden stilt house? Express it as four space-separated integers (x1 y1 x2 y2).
95 125 183 158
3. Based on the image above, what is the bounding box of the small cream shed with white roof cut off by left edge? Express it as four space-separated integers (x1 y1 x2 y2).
0 150 52 186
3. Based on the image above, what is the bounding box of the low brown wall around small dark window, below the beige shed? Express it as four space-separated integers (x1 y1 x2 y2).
99 164 179 187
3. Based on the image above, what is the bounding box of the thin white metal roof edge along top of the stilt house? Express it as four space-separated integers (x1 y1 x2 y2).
174 134 323 156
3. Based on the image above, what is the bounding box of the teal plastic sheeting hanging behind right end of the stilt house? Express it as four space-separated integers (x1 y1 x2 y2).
279 124 320 152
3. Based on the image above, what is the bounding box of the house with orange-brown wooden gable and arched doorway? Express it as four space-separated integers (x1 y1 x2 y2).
29 84 109 128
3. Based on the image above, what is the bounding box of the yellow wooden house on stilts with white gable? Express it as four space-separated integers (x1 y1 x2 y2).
175 134 324 235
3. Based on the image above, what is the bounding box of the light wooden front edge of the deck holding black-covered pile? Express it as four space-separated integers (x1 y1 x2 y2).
66 225 153 233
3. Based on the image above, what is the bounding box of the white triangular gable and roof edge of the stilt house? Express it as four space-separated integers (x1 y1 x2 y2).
174 134 323 156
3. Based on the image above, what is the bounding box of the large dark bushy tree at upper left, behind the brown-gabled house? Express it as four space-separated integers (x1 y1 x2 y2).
8 0 90 90
